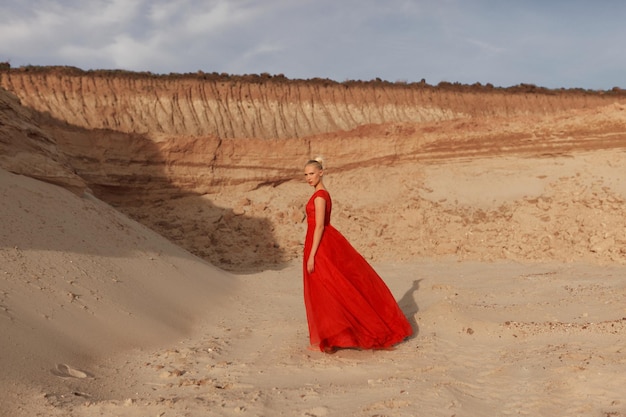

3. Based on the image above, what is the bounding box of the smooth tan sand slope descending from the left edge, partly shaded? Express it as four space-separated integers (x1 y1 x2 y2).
0 170 236 415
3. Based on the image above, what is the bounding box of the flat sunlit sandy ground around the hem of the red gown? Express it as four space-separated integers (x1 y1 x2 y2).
4 261 626 416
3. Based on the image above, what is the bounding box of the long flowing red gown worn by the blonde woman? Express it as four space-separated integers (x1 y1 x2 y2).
303 190 413 351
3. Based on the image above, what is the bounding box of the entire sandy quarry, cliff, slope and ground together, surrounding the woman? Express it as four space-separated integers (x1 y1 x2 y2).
0 69 626 417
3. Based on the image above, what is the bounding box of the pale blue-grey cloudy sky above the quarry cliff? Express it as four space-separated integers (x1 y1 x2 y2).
0 0 626 90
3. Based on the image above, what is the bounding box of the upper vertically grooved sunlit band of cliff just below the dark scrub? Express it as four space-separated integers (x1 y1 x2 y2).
0 71 607 139
